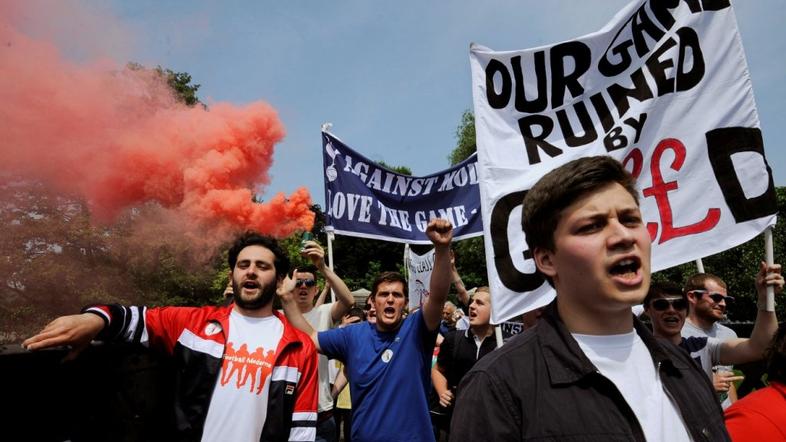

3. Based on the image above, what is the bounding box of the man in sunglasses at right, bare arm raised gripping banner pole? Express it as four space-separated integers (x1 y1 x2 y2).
644 274 783 391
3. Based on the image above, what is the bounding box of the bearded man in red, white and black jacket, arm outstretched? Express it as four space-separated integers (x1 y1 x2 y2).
23 233 317 441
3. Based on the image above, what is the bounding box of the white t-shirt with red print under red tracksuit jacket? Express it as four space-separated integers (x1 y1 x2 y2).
202 309 284 442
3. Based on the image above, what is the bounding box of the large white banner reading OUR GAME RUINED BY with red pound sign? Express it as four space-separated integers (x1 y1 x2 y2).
470 0 777 323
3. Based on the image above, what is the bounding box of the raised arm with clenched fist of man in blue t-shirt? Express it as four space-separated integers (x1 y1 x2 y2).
423 218 453 331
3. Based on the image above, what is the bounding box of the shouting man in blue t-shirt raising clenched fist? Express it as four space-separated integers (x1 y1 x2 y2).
278 219 453 441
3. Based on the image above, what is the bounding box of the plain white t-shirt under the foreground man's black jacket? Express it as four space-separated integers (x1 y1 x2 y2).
573 331 691 441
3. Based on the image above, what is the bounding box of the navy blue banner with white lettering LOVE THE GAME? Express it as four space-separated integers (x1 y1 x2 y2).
322 132 483 244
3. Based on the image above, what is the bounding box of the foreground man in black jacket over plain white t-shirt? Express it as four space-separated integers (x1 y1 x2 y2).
451 156 729 441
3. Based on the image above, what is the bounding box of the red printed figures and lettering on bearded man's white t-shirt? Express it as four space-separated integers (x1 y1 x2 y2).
221 342 276 394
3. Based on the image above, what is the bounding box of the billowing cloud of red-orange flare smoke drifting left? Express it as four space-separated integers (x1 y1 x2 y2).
0 0 314 237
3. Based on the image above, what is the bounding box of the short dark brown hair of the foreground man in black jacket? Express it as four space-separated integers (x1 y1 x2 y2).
521 155 639 252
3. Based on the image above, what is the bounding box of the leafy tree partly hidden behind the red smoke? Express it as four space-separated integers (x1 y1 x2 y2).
0 63 214 344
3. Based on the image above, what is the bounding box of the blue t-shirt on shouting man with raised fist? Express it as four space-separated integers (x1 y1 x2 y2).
319 310 437 441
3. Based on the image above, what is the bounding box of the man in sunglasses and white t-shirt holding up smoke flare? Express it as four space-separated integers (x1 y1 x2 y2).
293 241 355 442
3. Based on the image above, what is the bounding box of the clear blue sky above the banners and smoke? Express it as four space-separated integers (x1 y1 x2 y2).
30 0 786 207
